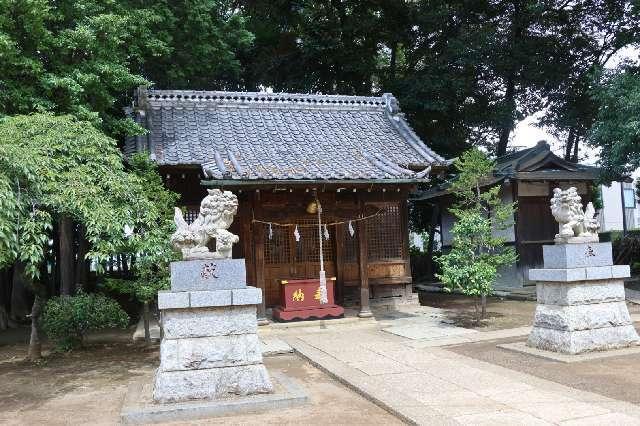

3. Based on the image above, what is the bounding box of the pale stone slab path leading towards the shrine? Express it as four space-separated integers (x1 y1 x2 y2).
283 327 640 425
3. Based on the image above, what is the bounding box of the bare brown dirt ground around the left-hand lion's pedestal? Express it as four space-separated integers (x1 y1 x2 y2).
0 339 401 425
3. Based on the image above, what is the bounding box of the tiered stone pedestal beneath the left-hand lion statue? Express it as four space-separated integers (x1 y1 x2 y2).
158 259 273 402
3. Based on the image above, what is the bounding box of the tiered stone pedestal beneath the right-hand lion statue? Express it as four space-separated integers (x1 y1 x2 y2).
527 243 640 354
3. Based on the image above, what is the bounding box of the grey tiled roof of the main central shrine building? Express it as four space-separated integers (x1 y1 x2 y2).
125 90 447 180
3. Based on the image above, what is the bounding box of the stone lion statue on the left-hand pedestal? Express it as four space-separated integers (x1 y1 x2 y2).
171 189 239 260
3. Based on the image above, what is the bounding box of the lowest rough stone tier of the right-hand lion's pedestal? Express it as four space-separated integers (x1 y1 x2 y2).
527 325 640 354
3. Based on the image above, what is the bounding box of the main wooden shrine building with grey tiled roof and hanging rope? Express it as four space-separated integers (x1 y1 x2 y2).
125 89 448 318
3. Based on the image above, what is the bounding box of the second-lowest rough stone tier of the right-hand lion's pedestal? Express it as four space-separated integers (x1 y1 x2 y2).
533 302 631 331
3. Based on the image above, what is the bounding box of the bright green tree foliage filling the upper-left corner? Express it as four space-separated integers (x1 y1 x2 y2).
0 0 165 136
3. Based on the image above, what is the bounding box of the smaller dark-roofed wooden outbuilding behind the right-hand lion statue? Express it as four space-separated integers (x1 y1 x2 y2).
412 141 600 291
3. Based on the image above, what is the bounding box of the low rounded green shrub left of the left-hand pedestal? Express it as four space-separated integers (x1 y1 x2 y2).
42 293 129 350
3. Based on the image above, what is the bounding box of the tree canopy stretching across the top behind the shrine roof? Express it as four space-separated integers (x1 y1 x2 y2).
0 0 640 159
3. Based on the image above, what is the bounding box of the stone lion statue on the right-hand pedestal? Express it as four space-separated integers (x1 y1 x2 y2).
551 187 600 244
